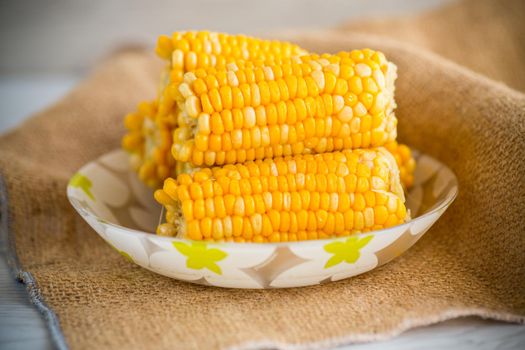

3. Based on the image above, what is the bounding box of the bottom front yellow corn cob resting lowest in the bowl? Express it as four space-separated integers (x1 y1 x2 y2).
155 147 408 242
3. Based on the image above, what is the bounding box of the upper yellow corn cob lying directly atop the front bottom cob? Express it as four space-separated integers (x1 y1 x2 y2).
172 49 397 166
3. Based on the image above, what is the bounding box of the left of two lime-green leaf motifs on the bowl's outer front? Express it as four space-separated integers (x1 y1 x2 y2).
172 241 228 275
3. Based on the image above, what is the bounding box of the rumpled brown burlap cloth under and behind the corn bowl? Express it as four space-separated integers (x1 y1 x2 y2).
0 0 525 349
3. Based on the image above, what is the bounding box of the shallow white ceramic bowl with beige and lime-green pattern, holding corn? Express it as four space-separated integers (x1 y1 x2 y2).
67 150 458 288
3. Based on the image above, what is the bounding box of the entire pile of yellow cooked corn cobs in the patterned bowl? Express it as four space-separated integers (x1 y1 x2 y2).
123 31 415 242
